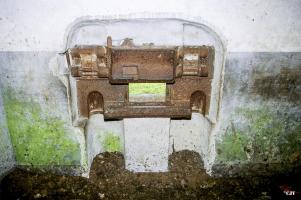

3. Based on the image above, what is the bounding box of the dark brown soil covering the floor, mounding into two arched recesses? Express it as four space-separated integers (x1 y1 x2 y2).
0 151 301 200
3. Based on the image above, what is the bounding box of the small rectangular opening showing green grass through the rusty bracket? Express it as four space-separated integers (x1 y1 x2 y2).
129 83 166 102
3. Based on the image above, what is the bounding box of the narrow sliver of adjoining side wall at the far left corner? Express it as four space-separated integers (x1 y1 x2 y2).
0 87 15 180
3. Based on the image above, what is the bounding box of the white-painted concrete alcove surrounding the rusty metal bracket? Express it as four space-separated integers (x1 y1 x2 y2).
61 18 225 171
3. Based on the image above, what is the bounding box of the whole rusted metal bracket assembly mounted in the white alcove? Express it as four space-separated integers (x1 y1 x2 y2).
66 37 214 119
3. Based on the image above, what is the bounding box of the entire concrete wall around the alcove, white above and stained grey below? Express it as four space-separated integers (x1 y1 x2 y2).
0 0 301 177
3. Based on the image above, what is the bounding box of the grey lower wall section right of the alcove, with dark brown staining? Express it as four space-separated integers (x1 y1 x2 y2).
215 53 301 171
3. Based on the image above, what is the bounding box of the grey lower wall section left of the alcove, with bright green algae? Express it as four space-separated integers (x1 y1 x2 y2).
0 52 85 174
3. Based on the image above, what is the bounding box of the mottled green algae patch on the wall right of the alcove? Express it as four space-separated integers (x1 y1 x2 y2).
217 106 301 162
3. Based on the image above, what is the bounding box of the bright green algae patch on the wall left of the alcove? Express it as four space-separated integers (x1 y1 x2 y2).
4 89 80 166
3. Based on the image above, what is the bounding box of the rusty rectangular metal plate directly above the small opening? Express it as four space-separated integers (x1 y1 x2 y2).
110 48 175 83
